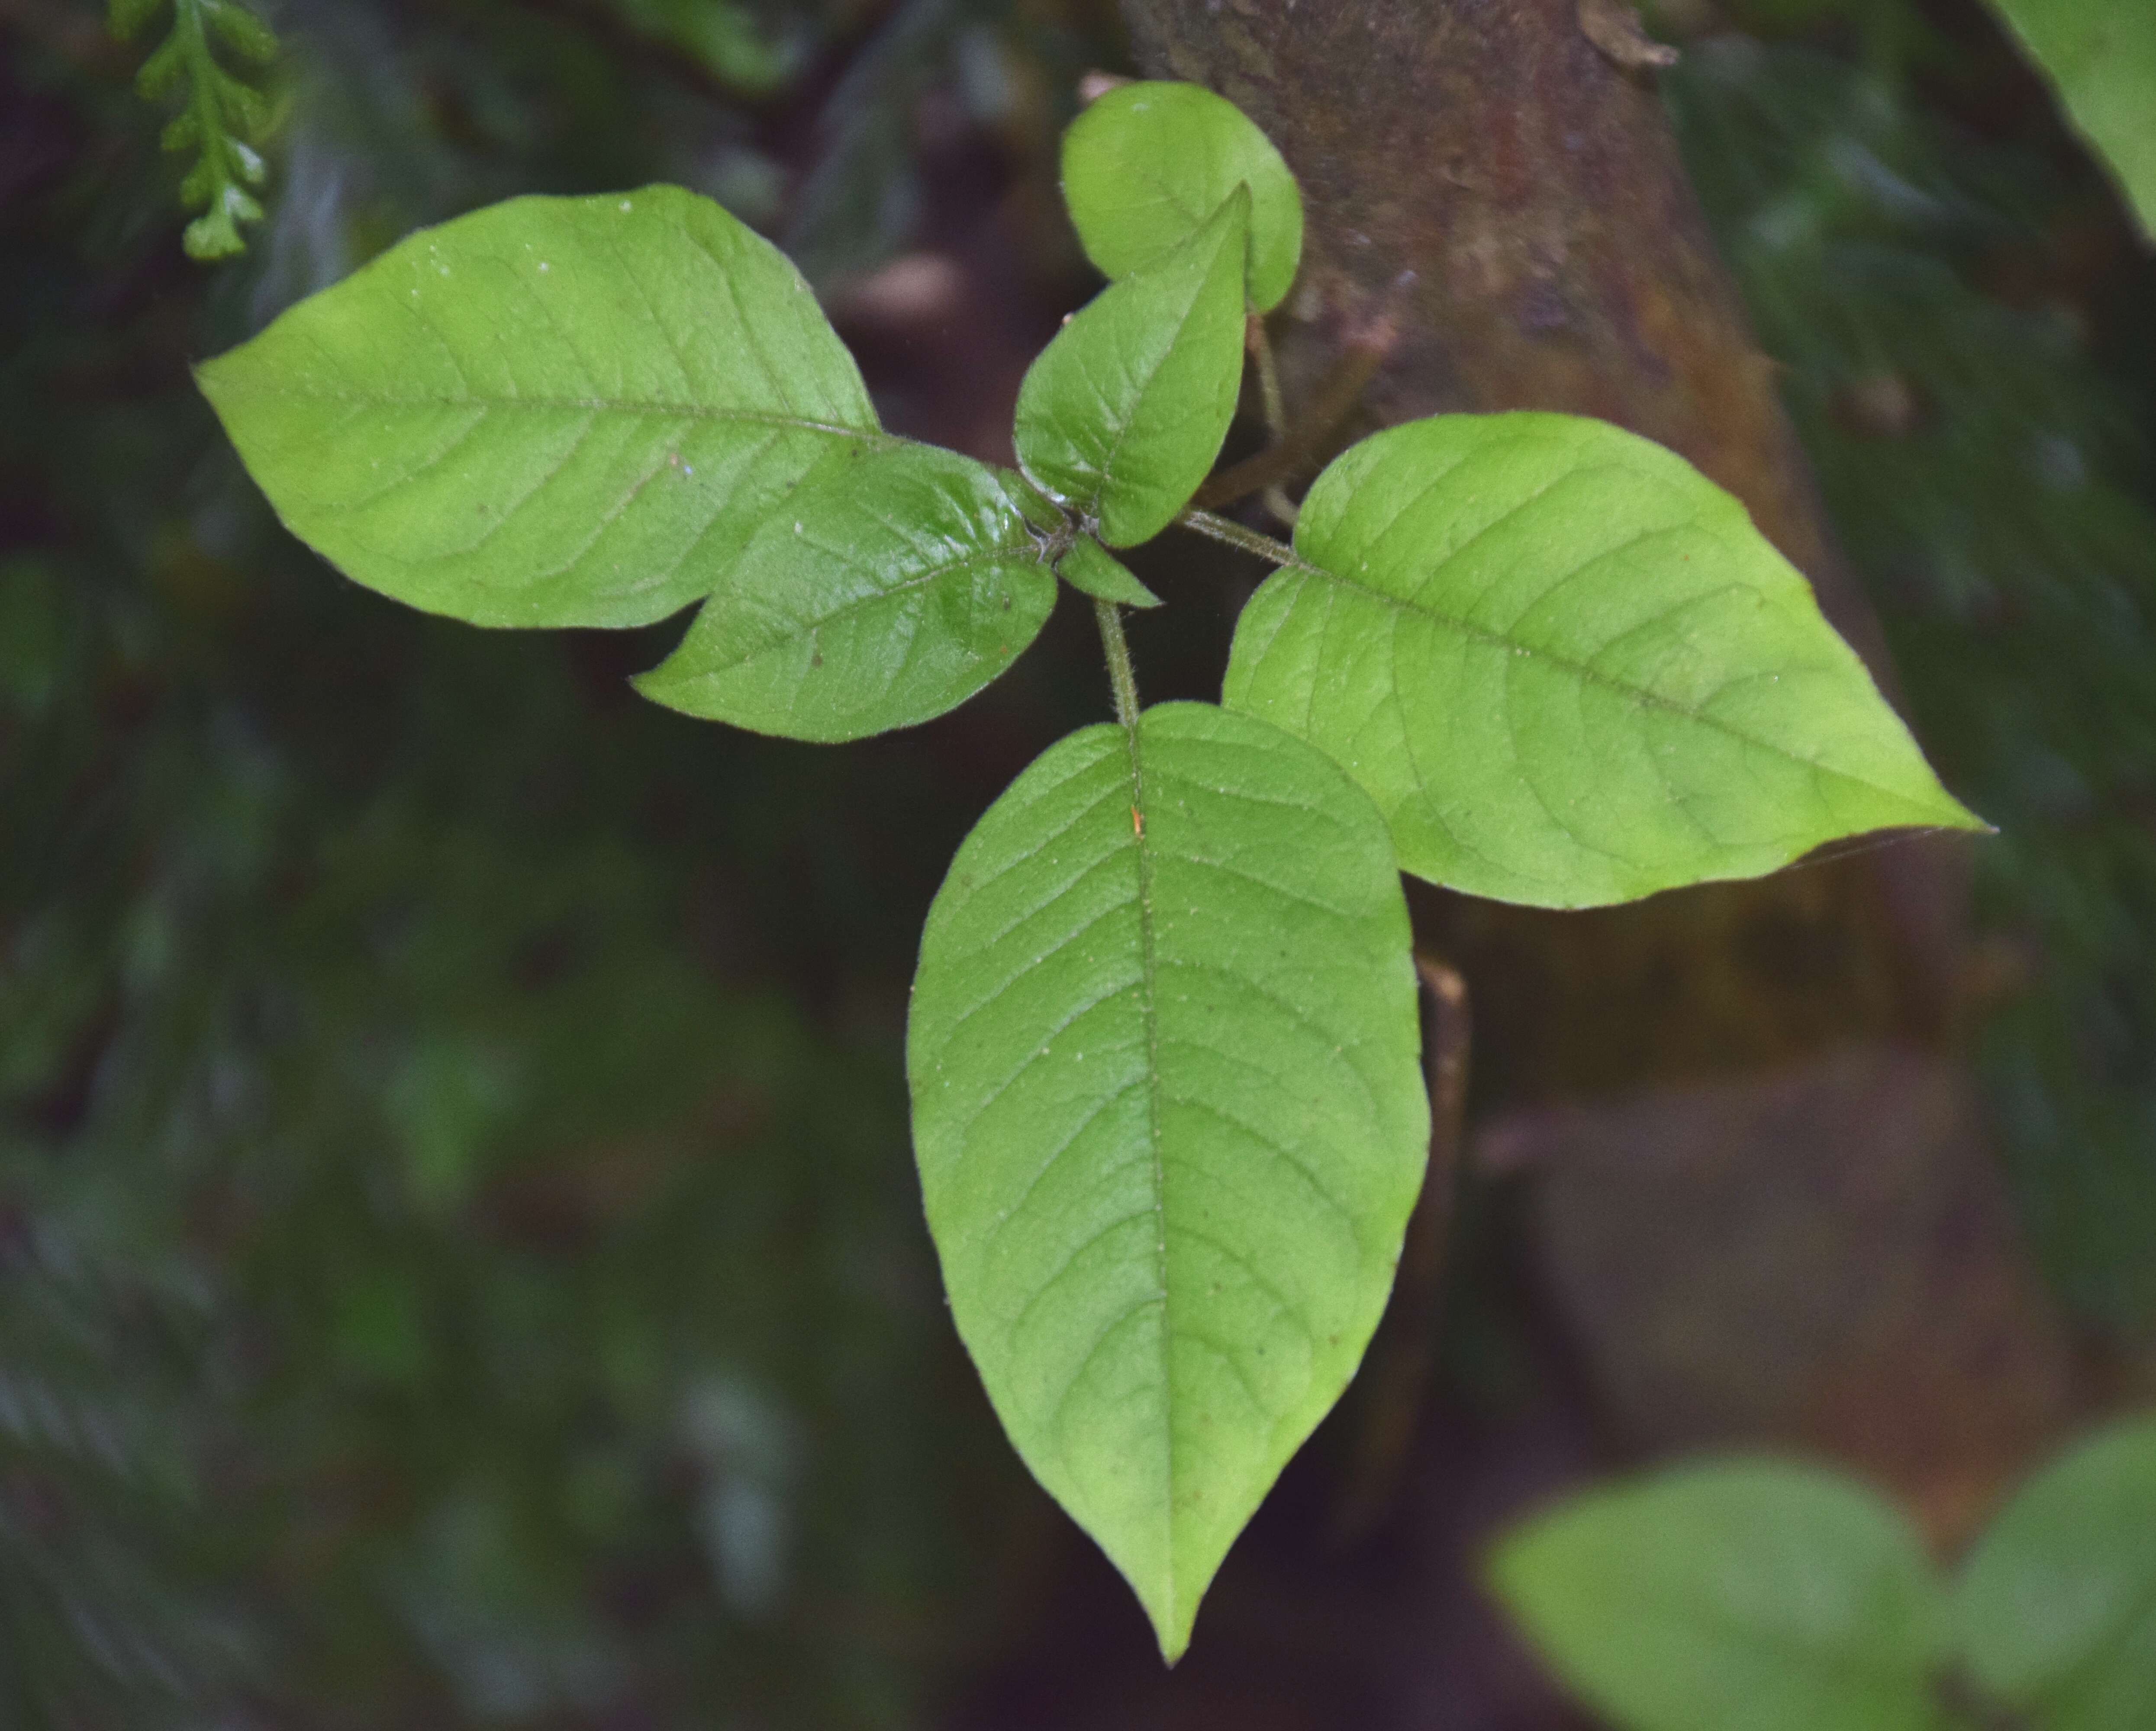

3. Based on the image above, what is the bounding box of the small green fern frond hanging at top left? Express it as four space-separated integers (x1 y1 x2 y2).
108 0 276 261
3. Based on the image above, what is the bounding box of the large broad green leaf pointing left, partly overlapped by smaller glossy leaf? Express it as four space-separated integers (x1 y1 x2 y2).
198 185 880 625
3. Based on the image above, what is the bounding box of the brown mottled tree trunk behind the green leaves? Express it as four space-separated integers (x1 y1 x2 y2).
1123 0 2072 1541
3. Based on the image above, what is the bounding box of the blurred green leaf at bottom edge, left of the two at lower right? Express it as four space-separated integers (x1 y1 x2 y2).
1490 1461 1943 1731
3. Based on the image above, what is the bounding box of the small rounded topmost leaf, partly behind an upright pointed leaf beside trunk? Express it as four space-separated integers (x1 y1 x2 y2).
1063 82 1302 312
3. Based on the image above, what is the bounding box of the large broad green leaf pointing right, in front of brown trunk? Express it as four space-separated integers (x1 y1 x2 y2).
1225 414 1982 907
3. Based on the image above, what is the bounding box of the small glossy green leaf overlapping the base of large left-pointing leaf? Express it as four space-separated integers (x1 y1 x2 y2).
634 444 1057 740
